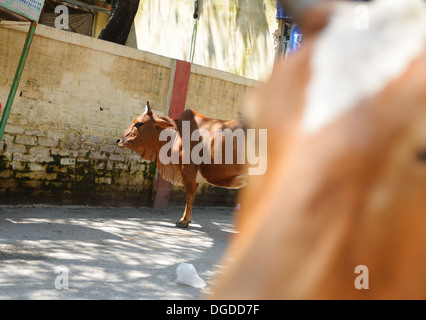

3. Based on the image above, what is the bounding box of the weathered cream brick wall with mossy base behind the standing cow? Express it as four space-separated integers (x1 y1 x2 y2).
0 22 256 205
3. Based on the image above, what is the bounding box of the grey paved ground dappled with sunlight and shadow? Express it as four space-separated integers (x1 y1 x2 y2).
0 205 234 299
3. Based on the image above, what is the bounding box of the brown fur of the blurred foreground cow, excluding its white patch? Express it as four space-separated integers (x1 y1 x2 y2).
212 1 426 299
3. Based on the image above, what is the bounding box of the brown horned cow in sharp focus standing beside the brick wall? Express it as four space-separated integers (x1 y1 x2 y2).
117 102 246 228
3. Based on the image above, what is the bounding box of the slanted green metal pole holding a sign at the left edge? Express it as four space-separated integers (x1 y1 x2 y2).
0 22 37 141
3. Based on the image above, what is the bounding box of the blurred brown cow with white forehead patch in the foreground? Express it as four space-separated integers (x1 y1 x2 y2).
212 0 426 300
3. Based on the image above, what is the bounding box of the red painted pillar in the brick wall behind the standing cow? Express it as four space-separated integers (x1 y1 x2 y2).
153 60 191 208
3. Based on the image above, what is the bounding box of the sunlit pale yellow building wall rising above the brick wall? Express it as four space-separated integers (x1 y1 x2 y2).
128 0 278 80
